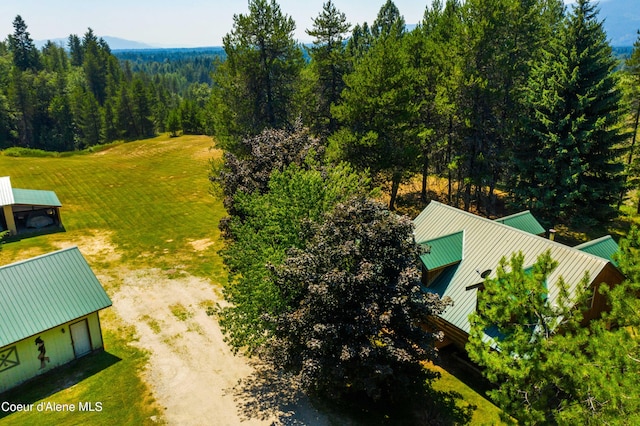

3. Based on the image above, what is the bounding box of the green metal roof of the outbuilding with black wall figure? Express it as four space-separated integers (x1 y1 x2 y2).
0 247 111 347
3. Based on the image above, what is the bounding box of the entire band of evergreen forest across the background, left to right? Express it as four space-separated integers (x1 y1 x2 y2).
0 0 638 230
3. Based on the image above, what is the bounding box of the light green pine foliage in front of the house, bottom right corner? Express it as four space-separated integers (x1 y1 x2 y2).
467 248 640 424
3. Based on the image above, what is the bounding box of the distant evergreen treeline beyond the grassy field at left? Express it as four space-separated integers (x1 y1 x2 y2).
0 16 210 151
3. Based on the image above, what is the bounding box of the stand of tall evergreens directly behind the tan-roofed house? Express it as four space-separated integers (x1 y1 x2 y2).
212 0 637 231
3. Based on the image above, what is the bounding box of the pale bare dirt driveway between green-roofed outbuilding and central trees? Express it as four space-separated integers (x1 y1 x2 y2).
112 269 328 425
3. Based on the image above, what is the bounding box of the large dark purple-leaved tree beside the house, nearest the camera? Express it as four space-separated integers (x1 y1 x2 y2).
271 197 445 408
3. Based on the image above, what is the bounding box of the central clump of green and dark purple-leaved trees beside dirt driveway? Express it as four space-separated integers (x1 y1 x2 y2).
211 121 458 418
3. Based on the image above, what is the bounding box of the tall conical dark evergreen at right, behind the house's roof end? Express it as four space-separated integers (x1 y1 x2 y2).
515 0 625 225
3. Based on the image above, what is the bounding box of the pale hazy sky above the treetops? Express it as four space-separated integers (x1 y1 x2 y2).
0 0 640 47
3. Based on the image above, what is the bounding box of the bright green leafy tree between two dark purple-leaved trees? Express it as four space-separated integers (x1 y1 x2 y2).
220 164 368 353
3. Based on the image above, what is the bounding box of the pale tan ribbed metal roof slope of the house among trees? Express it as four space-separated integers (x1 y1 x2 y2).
413 201 609 340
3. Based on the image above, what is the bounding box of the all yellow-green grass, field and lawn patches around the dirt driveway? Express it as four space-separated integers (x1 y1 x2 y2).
0 135 499 425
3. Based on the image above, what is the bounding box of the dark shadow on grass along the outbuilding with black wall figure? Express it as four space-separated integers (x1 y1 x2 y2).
0 351 122 419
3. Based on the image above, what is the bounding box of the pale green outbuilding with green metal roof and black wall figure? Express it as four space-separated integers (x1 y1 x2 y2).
0 247 111 393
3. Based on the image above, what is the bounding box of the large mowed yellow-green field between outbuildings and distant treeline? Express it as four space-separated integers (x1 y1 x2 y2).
0 135 225 280
